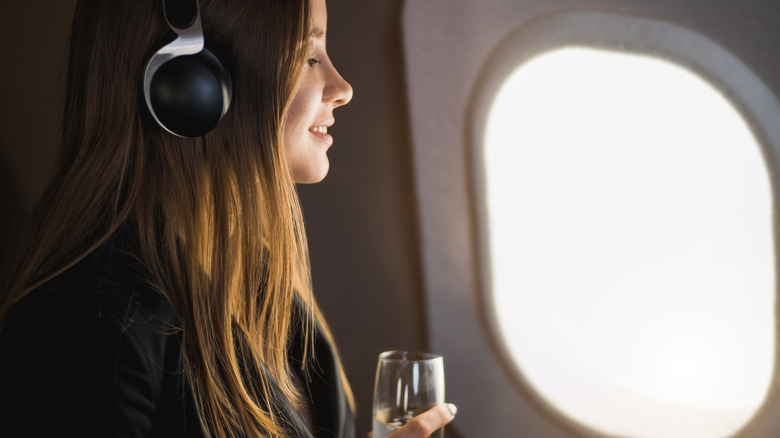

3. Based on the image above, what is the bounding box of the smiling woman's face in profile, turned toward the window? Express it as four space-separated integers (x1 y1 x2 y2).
283 0 352 183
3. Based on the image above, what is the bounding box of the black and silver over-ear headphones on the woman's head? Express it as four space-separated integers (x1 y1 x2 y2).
142 0 233 137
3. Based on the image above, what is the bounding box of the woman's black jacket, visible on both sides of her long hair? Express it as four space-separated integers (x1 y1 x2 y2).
0 243 354 438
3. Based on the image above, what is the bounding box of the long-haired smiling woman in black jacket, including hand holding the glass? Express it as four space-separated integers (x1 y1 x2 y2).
0 0 454 437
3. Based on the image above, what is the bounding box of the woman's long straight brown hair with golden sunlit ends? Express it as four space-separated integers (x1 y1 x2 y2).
0 0 354 436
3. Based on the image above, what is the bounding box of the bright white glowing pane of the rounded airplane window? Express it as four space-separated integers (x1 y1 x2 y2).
484 47 775 438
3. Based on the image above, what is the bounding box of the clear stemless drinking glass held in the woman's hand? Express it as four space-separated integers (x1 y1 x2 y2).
372 350 444 438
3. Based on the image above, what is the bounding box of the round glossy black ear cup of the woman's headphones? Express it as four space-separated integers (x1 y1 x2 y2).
149 47 233 137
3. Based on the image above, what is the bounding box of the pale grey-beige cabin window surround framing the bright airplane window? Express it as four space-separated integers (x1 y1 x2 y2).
403 6 780 438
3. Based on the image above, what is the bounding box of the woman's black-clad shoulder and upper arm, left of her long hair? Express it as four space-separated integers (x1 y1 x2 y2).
0 245 196 436
